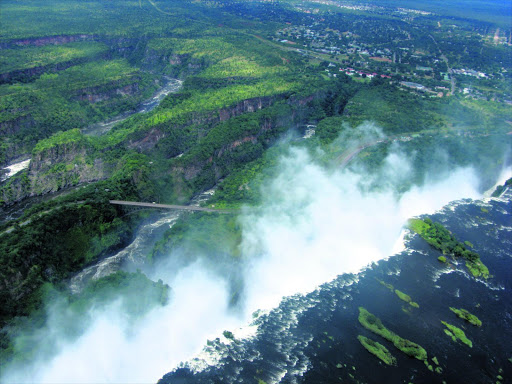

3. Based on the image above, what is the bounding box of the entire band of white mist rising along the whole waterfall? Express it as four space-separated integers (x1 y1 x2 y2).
2 136 504 383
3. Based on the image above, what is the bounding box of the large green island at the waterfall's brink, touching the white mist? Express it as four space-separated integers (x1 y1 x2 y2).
408 218 489 279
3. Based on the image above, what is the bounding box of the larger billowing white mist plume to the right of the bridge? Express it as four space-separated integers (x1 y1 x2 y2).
241 149 479 311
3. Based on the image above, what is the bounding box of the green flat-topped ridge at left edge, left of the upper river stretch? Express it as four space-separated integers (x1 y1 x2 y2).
0 59 155 153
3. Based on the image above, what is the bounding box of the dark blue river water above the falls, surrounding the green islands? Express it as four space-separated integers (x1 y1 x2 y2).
161 192 512 384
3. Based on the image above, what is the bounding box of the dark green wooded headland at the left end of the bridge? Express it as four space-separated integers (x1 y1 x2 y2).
0 177 150 325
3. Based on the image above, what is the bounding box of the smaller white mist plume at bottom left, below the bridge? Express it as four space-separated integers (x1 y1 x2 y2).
3 264 240 384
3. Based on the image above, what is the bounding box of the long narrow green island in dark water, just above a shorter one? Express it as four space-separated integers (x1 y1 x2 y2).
359 307 427 361
